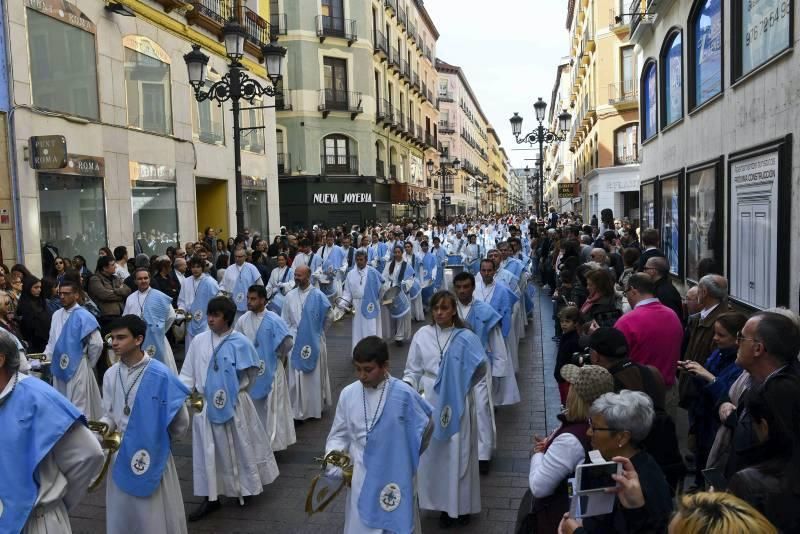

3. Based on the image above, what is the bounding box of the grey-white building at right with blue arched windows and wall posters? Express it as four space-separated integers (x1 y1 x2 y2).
630 0 800 311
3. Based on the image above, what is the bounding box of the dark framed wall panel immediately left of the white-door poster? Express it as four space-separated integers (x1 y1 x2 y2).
686 165 722 282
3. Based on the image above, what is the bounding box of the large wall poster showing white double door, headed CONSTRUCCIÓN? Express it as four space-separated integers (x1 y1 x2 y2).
728 150 791 309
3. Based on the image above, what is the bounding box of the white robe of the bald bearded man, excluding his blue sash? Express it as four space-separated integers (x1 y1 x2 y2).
281 284 333 420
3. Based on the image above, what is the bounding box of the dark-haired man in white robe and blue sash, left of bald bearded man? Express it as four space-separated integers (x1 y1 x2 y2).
234 280 297 452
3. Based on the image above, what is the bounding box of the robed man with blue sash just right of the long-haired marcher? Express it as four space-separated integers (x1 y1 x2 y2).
453 272 519 474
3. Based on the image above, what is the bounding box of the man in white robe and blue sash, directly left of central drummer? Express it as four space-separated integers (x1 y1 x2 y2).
342 250 383 348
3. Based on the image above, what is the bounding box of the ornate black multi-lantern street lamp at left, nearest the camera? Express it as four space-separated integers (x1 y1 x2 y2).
183 19 286 239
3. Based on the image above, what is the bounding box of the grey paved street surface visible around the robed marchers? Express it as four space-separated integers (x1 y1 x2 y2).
72 295 558 534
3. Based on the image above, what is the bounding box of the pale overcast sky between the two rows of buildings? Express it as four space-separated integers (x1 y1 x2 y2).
425 0 569 167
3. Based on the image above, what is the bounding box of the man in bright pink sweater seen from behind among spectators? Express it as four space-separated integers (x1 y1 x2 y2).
614 273 683 420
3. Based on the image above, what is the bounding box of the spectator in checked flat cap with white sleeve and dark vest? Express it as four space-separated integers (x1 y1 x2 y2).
528 365 613 532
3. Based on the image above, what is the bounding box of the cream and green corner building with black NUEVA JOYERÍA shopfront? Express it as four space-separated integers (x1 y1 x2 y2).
272 0 439 227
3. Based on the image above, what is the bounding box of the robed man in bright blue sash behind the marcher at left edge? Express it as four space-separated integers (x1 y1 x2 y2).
44 280 103 420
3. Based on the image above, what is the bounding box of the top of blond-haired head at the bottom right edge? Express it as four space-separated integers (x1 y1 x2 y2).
669 492 776 534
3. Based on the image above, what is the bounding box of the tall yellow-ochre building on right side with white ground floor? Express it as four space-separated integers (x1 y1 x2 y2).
567 0 639 226
